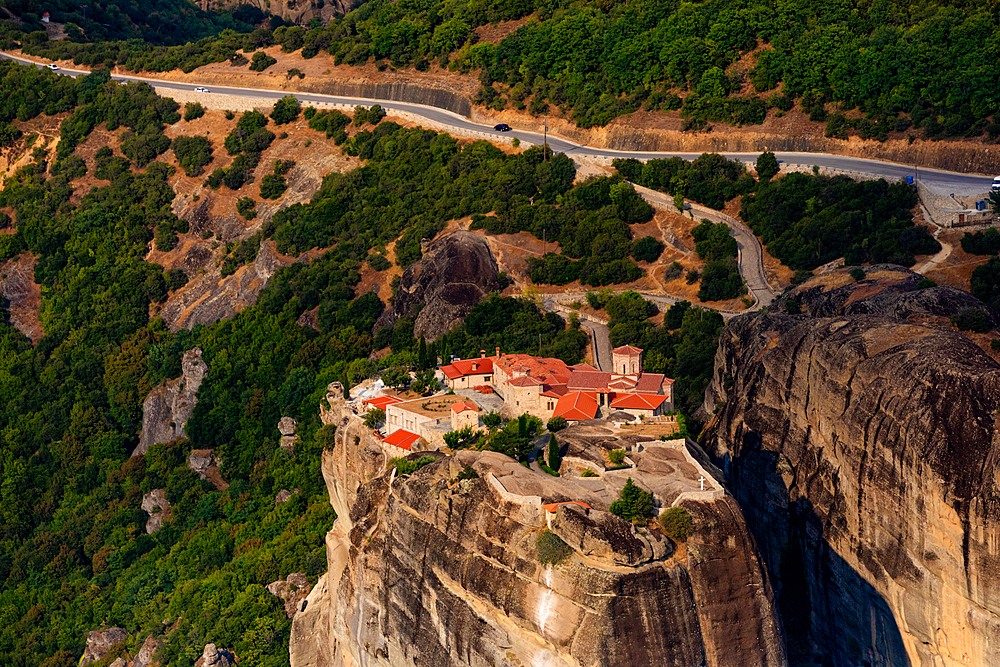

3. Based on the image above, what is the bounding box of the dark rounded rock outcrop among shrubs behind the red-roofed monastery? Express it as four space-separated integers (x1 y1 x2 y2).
375 232 499 339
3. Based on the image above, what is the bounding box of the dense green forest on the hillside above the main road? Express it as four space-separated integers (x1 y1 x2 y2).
7 0 1000 140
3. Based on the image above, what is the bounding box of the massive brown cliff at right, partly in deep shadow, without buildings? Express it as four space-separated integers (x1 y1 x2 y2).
706 267 1000 667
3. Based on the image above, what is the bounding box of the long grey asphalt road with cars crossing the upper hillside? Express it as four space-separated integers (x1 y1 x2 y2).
0 54 993 192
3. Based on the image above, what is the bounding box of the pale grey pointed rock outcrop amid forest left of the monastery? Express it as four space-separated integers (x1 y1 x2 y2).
132 347 208 456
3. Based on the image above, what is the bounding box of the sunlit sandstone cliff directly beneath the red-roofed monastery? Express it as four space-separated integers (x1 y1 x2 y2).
290 392 786 667
